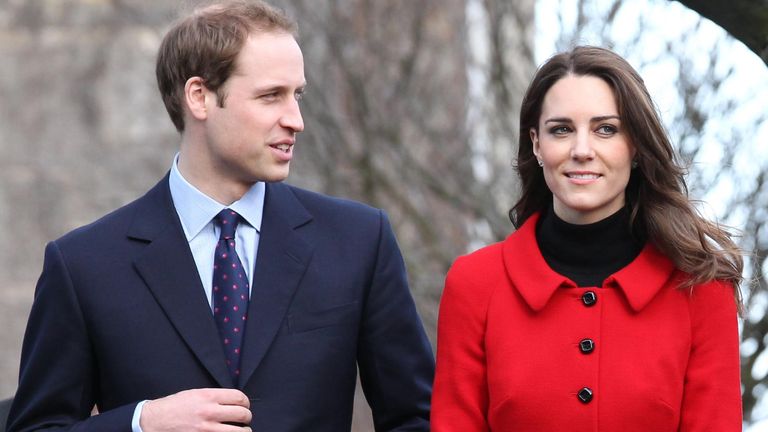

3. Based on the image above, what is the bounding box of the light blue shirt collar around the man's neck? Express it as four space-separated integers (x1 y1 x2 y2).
168 154 265 241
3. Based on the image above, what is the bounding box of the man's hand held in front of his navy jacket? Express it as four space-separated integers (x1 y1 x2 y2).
139 388 251 432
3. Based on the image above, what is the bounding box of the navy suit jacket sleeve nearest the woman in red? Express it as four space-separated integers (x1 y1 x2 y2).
358 212 435 432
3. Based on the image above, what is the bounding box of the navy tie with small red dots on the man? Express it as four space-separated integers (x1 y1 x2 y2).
213 209 248 387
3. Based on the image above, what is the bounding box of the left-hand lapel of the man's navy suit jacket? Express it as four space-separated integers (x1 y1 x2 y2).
128 176 232 387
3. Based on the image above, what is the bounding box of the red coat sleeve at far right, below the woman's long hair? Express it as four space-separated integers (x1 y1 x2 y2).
679 282 742 432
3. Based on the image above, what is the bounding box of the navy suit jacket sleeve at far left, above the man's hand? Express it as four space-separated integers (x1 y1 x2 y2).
7 242 136 432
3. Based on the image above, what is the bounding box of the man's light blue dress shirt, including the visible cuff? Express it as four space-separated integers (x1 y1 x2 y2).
131 154 266 432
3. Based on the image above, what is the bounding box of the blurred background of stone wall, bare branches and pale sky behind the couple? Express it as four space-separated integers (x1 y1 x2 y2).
0 0 768 432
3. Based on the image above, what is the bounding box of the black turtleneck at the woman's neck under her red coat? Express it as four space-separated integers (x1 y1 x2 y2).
536 207 644 287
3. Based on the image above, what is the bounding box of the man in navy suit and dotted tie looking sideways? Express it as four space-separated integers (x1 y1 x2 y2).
8 1 434 432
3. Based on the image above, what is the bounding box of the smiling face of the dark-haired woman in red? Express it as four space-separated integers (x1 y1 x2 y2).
530 75 635 224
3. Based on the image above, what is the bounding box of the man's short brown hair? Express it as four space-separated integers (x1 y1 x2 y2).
155 0 297 132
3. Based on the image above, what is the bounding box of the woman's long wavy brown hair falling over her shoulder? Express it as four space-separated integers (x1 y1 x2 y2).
510 46 744 305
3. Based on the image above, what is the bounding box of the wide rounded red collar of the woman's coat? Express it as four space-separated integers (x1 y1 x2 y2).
502 213 675 312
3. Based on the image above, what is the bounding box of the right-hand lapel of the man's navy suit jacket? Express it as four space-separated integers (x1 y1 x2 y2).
240 183 313 387
